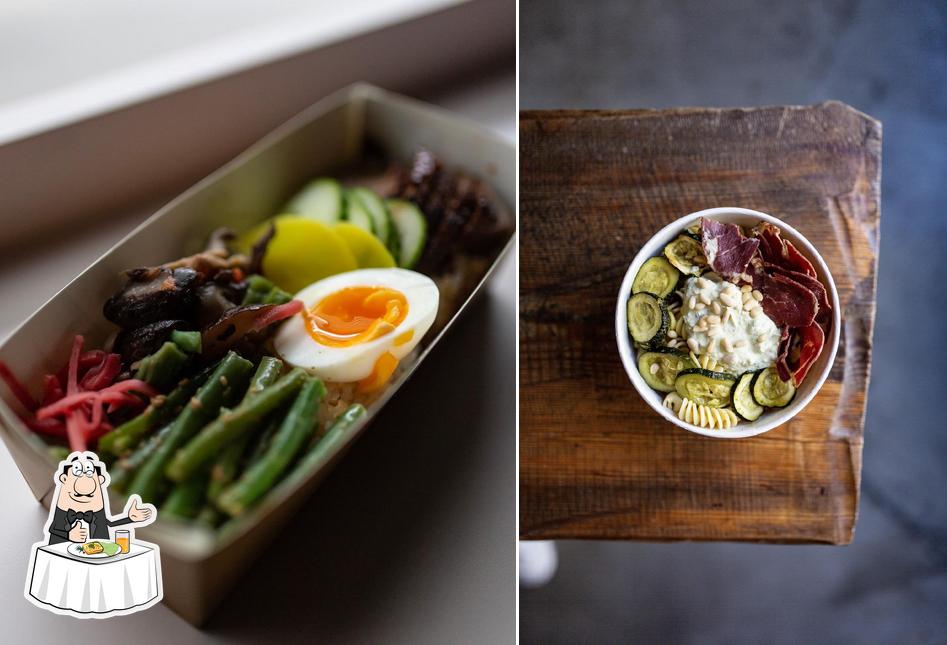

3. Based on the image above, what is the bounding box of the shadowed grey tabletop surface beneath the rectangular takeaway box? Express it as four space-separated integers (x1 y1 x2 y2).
0 71 516 645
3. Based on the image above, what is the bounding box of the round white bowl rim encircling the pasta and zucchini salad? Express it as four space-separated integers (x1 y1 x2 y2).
615 207 841 439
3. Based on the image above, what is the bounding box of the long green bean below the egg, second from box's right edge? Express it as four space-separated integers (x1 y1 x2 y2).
217 378 326 516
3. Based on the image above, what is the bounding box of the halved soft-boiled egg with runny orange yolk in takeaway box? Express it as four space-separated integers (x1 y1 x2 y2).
274 268 438 392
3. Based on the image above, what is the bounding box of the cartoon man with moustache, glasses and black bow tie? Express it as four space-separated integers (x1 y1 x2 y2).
47 452 154 544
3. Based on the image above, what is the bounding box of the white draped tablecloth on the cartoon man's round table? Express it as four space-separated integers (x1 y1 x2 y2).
30 542 159 613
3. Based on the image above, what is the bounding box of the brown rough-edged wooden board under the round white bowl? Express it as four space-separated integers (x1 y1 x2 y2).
520 102 881 544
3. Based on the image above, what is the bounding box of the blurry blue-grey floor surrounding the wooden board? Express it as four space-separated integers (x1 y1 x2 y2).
520 0 947 644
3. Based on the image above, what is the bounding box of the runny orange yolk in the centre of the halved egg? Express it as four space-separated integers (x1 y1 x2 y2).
302 287 408 347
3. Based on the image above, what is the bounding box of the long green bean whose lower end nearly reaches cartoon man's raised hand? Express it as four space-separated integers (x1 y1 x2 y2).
129 352 254 503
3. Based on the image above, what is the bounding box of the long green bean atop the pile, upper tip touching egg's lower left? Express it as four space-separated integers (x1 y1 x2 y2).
166 368 307 482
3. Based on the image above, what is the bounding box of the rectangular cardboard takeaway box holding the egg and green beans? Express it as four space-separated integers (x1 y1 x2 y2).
0 84 516 624
